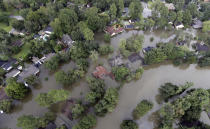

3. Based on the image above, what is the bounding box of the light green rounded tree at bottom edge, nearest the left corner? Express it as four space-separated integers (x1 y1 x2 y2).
17 115 39 129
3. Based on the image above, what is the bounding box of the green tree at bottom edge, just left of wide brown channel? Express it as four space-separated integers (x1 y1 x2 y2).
72 115 96 129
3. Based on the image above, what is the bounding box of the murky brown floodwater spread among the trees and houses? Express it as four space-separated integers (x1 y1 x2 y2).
0 31 210 129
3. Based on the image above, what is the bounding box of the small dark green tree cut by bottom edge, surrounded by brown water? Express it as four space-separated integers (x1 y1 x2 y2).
120 120 138 129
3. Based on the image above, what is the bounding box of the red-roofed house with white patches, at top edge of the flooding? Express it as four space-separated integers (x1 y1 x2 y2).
104 25 124 36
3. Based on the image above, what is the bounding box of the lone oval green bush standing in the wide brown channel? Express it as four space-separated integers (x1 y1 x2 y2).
133 100 153 119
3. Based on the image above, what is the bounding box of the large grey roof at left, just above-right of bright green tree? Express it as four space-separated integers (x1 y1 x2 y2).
19 65 39 79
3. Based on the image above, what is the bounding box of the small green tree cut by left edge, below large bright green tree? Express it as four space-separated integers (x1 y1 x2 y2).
0 99 13 113
